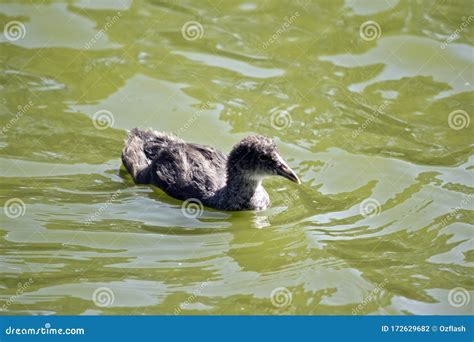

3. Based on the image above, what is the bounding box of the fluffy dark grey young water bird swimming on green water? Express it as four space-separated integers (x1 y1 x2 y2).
122 128 301 211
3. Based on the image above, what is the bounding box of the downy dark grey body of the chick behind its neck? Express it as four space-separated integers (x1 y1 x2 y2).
122 129 227 204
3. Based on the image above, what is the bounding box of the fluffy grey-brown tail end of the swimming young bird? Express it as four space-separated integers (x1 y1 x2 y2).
122 128 150 184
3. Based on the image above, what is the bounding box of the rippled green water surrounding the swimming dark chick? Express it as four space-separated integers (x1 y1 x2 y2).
0 0 474 315
